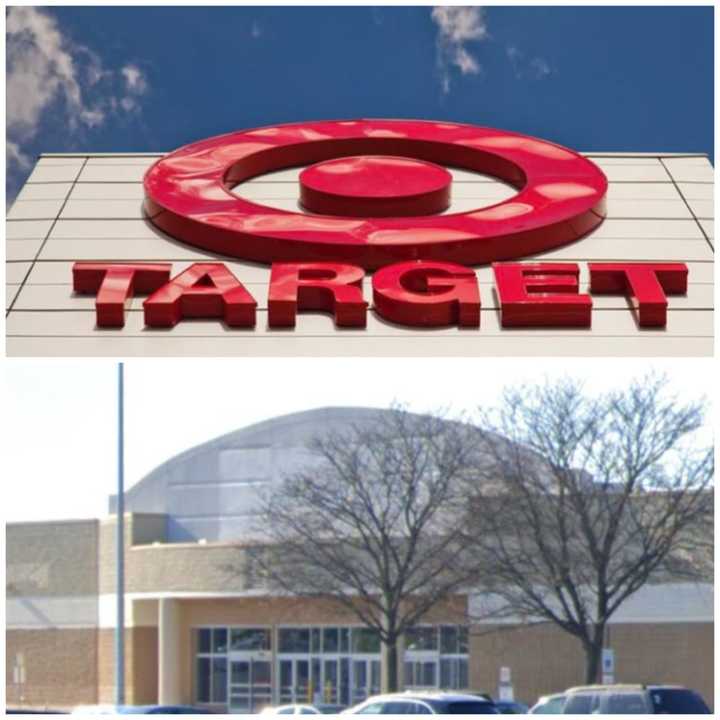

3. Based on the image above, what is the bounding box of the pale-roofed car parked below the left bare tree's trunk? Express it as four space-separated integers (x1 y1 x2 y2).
343 692 500 715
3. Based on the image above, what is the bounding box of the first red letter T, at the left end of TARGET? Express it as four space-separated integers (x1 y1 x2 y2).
73 263 171 327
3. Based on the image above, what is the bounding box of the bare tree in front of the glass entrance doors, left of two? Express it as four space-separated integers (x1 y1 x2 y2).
250 407 477 691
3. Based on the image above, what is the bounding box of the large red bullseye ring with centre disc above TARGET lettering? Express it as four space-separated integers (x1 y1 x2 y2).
144 120 607 269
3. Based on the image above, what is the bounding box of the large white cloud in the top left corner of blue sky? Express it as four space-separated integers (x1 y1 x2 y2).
6 6 148 191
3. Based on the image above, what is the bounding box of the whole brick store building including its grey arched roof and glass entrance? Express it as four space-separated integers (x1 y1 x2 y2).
6 408 713 712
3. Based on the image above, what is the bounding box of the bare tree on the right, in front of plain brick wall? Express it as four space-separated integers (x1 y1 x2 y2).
468 377 713 682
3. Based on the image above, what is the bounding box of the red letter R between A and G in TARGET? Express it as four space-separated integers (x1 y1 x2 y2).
268 262 367 327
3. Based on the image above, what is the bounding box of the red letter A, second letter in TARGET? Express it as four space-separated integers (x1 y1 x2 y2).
143 263 257 327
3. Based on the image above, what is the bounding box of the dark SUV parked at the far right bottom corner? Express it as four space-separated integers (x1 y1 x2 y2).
563 685 710 715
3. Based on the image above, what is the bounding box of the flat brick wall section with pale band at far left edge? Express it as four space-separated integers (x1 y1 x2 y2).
5 520 98 707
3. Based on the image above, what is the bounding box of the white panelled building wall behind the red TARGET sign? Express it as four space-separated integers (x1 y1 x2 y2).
6 121 714 357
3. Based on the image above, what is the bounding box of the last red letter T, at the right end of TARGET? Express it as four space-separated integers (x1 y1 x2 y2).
588 263 688 327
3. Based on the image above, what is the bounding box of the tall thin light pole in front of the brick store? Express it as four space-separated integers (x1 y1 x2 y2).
115 363 125 705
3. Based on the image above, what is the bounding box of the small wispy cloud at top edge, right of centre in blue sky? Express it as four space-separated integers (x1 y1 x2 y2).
431 5 490 93
